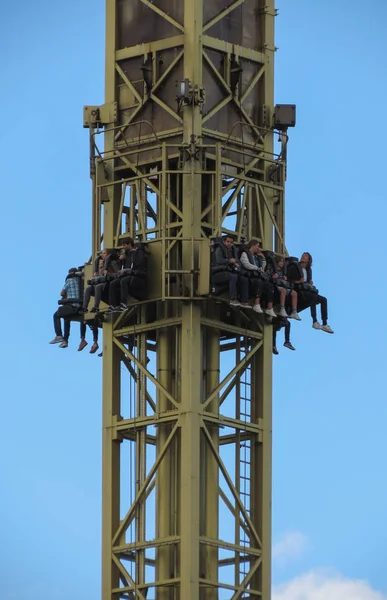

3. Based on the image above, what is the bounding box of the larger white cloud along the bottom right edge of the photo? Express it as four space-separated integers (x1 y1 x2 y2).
272 570 387 600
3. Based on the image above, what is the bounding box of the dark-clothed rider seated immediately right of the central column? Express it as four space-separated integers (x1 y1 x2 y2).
212 235 251 308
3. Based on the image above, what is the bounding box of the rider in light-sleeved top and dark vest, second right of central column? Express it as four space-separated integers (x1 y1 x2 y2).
241 240 277 318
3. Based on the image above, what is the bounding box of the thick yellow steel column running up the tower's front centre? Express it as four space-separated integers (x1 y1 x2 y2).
180 0 203 600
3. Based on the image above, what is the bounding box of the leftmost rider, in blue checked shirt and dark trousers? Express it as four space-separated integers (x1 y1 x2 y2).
50 268 82 348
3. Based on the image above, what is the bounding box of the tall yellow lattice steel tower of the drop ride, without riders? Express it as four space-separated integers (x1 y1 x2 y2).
84 0 291 600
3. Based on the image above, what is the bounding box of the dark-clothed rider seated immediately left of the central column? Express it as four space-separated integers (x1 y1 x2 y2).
107 238 147 313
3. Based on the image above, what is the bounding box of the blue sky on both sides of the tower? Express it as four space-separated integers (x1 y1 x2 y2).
0 0 387 600
